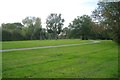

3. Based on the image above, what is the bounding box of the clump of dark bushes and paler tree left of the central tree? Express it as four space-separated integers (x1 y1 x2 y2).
2 17 47 41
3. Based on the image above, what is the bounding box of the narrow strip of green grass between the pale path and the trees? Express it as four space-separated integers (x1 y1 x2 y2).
2 39 90 50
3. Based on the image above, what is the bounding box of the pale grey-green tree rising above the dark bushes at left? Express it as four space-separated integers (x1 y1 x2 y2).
22 17 42 40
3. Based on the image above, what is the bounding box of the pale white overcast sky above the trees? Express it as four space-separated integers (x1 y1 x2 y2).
0 0 99 27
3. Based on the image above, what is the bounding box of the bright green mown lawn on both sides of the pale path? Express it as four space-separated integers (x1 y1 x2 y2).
2 40 118 78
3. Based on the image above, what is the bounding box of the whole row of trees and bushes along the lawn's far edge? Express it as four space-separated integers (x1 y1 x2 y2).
1 2 120 43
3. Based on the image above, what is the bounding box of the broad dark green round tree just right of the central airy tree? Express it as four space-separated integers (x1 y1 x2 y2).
69 15 92 39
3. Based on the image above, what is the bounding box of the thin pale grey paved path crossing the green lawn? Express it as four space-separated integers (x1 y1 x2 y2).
0 41 100 52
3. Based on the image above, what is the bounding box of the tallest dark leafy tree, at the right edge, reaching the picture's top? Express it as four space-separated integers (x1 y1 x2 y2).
93 2 120 43
